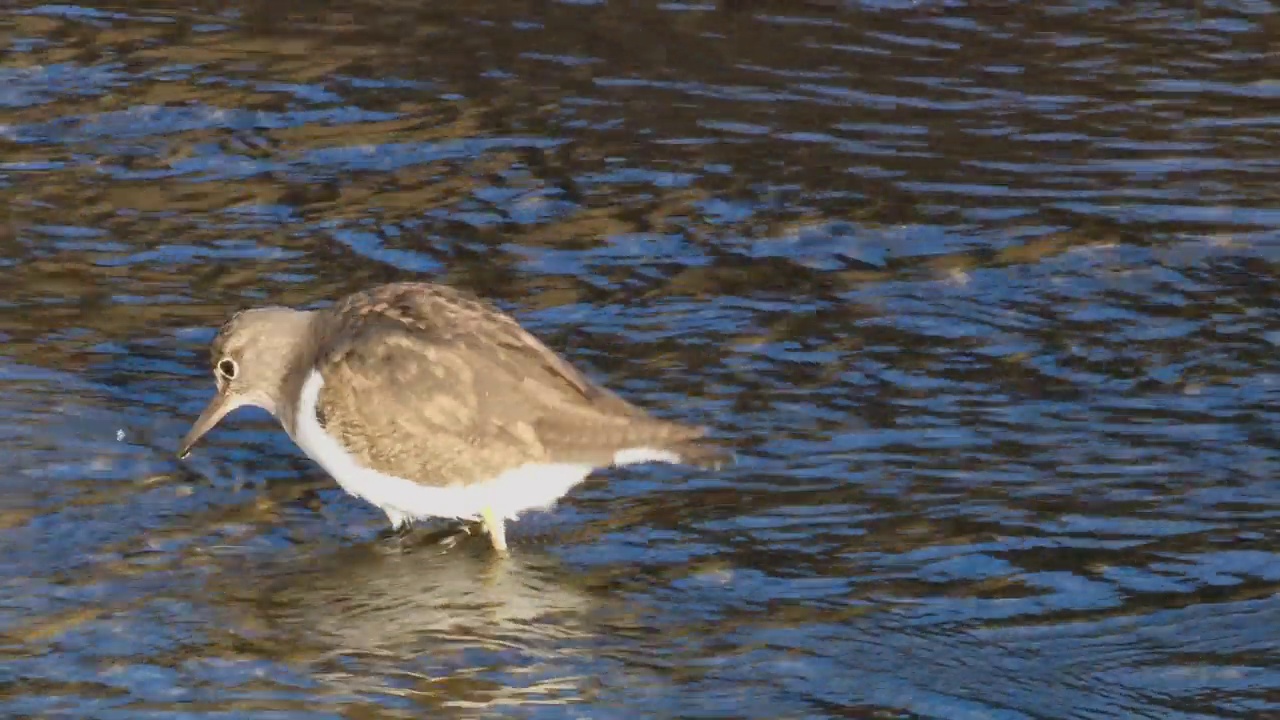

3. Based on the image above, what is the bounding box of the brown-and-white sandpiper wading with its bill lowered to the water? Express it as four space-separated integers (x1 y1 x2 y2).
178 283 730 553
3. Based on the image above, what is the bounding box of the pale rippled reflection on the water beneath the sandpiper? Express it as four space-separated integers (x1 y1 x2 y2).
237 533 595 657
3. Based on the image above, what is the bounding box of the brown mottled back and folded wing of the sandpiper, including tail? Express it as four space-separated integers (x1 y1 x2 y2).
316 283 701 486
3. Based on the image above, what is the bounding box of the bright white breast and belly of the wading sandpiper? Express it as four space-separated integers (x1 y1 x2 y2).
293 370 604 525
